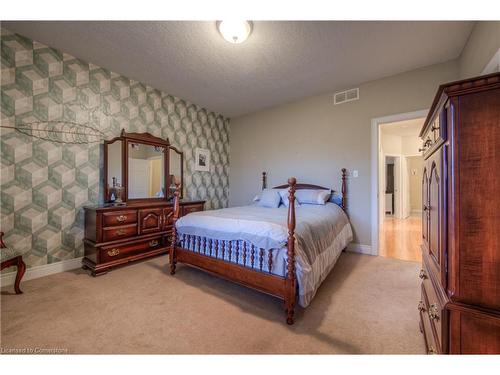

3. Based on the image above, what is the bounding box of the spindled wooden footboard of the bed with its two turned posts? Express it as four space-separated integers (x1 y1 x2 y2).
170 178 297 324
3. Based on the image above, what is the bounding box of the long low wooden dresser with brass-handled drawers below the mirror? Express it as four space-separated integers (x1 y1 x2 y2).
82 201 205 276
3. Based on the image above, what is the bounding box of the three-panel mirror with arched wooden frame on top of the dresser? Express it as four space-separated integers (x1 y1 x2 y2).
104 131 176 204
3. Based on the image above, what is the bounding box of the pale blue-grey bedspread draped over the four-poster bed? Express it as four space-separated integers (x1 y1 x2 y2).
176 203 352 307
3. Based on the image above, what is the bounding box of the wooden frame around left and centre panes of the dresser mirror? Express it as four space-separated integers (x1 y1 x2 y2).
104 129 170 203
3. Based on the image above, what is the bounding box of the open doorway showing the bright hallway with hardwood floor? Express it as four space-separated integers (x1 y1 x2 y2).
378 117 425 261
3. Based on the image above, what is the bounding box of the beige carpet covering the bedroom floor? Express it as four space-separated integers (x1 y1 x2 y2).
0 253 424 353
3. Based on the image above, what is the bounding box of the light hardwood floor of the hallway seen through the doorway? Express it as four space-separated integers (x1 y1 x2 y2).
379 215 422 262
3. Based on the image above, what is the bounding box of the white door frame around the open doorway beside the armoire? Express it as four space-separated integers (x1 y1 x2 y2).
371 109 429 255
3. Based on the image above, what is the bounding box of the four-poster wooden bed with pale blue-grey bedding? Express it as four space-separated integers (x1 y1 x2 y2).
170 169 352 324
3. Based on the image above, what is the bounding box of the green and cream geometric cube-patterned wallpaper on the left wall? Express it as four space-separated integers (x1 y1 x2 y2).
0 29 229 271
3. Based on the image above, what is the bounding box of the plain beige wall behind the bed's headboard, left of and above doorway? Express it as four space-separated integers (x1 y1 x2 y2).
230 61 458 245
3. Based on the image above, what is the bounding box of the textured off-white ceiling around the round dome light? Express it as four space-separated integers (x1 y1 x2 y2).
2 21 474 117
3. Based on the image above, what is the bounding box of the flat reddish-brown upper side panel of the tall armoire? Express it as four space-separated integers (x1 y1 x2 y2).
455 89 500 309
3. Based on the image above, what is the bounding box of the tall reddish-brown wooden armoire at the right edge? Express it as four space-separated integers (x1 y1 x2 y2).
418 73 500 354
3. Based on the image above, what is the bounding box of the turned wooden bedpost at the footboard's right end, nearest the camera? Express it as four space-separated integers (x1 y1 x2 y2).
285 177 297 324
